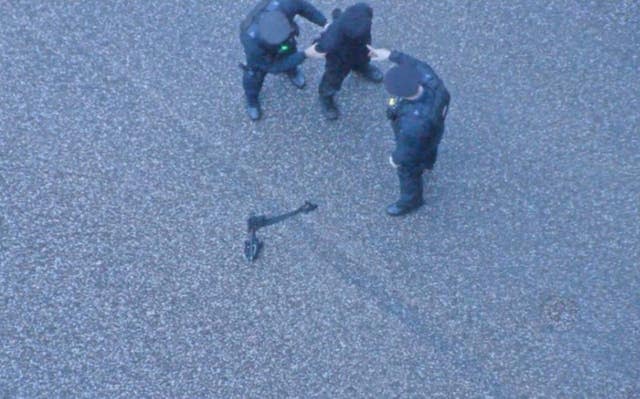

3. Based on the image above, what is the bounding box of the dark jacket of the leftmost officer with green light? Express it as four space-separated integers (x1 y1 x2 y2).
240 0 327 73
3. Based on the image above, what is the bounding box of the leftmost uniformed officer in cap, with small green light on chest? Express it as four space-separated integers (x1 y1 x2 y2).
240 0 327 120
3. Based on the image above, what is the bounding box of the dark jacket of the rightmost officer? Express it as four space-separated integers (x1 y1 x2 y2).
387 51 451 168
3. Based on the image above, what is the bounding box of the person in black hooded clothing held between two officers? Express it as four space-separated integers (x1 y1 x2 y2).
316 3 384 120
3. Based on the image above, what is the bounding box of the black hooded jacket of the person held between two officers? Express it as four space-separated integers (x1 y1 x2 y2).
316 3 373 66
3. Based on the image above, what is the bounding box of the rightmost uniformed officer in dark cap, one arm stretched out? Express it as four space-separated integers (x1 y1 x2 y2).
369 47 451 216
